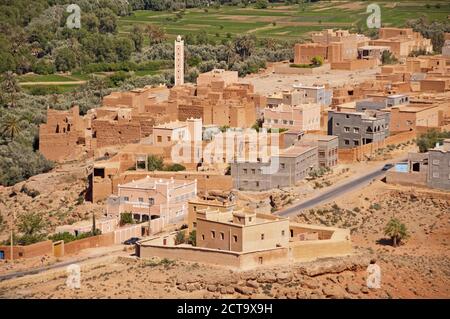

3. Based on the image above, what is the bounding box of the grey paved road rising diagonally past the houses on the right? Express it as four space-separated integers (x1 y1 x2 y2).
275 165 396 217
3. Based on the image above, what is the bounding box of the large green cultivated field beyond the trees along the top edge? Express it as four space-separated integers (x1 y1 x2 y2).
119 1 450 40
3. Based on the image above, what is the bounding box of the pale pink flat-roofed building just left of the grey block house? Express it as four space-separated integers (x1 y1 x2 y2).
263 103 320 131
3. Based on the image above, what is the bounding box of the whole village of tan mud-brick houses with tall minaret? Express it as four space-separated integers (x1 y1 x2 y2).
0 28 450 298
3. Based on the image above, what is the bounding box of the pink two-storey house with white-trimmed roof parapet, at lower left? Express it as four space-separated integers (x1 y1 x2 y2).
107 176 197 225
